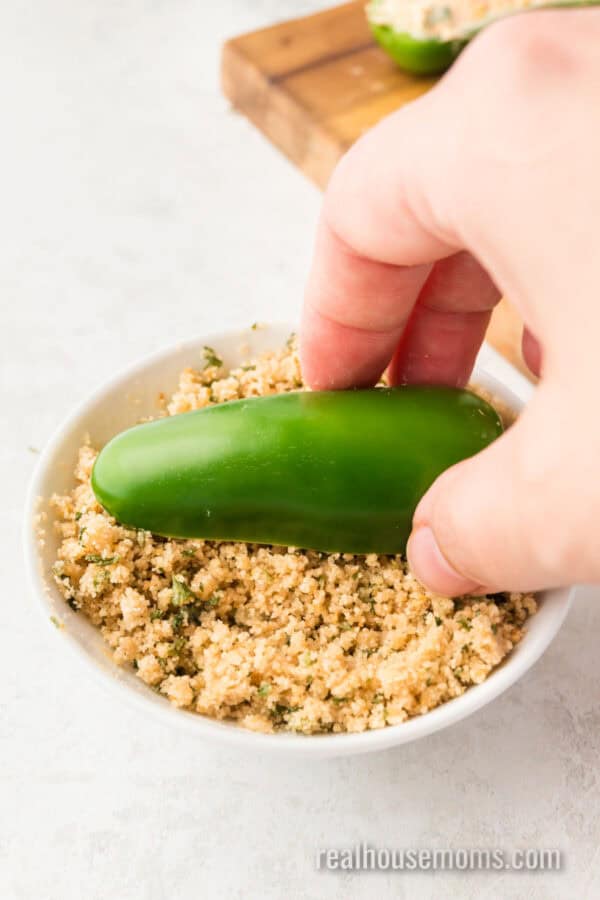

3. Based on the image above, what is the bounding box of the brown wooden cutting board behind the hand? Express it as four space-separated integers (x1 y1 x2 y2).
221 0 529 375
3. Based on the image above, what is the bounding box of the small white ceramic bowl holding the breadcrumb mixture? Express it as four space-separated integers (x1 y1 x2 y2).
24 325 572 757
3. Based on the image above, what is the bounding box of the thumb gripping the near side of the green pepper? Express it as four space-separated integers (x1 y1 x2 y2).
407 387 597 597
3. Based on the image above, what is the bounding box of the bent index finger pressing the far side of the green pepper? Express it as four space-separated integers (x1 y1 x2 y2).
300 96 462 388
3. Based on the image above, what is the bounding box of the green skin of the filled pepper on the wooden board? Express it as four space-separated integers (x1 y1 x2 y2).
370 23 468 75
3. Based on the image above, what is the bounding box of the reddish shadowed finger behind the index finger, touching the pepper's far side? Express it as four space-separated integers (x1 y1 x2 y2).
389 252 500 387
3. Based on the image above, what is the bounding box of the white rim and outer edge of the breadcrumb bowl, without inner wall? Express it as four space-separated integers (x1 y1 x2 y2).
22 322 575 758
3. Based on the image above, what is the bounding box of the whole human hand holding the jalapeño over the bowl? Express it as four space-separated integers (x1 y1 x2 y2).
300 10 600 596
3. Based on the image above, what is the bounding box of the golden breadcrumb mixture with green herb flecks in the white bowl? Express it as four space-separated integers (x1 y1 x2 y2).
52 340 536 734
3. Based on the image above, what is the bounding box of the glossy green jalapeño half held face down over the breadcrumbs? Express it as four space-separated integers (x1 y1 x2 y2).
92 386 502 554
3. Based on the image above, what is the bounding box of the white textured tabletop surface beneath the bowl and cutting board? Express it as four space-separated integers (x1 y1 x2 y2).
0 0 600 900
